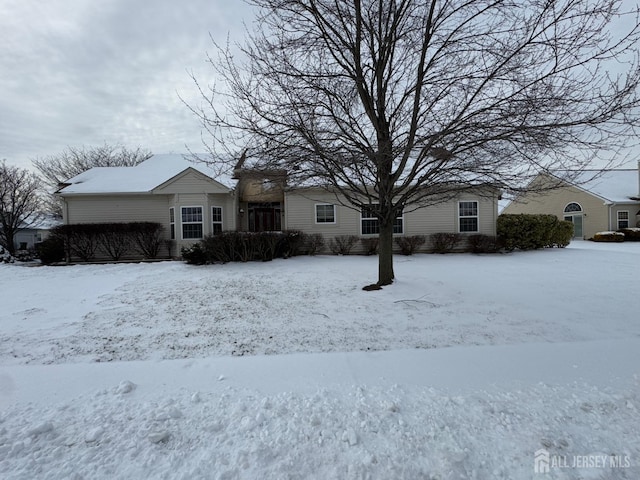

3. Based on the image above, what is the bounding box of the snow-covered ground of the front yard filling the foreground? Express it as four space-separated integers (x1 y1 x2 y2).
0 242 640 479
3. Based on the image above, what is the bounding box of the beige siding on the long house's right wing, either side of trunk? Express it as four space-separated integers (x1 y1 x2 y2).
285 191 497 251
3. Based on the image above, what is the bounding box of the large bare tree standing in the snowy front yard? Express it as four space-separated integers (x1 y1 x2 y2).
190 0 640 285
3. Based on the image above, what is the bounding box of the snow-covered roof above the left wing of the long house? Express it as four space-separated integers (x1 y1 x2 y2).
60 154 234 195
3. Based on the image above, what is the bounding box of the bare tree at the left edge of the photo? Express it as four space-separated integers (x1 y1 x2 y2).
0 160 42 255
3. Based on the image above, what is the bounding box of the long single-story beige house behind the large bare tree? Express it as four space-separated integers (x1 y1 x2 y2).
58 155 499 256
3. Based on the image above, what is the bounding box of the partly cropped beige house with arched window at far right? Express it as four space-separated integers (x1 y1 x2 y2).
501 163 640 239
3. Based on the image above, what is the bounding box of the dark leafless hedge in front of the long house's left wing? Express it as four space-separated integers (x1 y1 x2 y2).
38 222 164 264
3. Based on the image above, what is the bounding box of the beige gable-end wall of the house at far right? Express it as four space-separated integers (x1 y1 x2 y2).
502 177 615 239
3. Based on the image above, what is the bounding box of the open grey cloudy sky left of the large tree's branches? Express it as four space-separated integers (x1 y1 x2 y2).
0 0 253 167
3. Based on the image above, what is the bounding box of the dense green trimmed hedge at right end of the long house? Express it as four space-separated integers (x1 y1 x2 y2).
496 214 573 251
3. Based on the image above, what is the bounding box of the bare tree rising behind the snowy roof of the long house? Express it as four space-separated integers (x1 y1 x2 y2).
32 144 152 217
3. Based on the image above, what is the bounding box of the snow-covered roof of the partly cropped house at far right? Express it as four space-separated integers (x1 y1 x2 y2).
559 169 640 203
